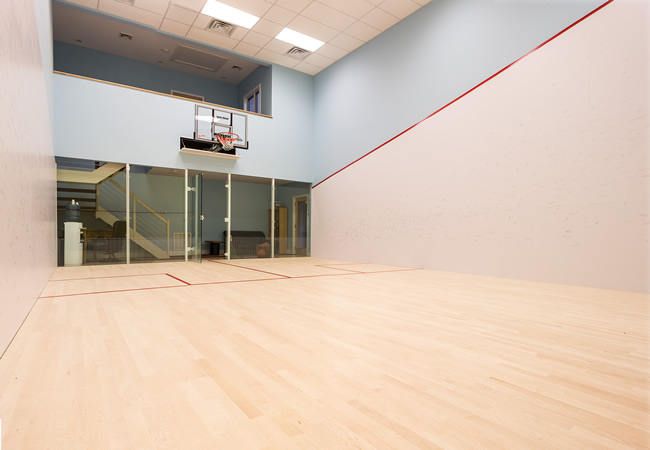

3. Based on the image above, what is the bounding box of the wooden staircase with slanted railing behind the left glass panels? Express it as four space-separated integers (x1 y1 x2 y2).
57 163 170 259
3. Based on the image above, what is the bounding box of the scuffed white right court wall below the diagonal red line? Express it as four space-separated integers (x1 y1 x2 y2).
312 0 650 291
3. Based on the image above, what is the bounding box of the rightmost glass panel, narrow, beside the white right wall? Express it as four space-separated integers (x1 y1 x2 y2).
275 180 311 257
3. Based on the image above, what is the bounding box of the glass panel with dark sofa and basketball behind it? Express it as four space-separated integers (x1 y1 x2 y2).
230 175 271 259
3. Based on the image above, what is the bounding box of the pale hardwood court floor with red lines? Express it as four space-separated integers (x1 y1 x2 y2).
0 258 650 450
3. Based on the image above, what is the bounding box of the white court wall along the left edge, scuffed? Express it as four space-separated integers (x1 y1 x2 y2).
0 0 56 355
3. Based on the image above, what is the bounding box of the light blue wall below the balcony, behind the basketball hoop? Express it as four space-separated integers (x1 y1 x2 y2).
54 62 313 182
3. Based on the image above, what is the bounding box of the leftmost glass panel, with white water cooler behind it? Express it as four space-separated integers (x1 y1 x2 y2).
56 158 126 266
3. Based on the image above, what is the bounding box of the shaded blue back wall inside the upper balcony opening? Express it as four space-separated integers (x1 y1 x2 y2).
54 41 242 108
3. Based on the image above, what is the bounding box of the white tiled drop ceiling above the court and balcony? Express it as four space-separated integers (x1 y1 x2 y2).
53 0 431 76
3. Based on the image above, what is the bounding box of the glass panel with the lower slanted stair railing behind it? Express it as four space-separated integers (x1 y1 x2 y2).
129 165 184 263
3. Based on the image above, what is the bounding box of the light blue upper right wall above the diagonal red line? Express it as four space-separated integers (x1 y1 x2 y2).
313 0 604 182
